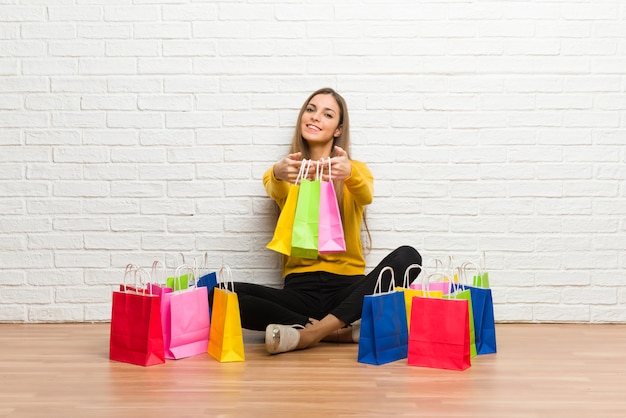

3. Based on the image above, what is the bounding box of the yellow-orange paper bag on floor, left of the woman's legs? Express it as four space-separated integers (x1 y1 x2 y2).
208 266 245 363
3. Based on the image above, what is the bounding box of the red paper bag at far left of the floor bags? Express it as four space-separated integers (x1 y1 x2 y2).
109 269 165 366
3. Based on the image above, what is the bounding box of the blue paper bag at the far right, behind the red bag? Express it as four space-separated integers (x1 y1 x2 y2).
460 263 497 354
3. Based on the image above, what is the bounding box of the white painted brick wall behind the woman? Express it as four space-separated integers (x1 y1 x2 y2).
0 0 626 323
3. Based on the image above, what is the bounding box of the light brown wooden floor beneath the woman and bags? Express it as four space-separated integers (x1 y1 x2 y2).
0 324 626 418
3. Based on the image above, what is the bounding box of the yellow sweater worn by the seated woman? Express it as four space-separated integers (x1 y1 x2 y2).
263 160 374 277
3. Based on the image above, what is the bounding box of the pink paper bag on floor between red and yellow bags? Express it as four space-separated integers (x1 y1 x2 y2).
163 265 210 359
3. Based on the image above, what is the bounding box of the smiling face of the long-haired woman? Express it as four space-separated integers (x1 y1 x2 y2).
300 94 341 145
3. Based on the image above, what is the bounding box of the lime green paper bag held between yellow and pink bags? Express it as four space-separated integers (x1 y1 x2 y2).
291 160 320 259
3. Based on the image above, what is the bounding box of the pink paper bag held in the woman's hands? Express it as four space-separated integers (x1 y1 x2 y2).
318 157 346 254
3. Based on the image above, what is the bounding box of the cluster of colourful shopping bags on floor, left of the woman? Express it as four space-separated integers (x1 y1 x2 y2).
109 261 244 366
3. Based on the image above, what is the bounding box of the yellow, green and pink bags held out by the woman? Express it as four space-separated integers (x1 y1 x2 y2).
267 158 346 259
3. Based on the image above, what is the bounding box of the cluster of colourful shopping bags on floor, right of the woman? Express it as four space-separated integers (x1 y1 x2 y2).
358 256 496 370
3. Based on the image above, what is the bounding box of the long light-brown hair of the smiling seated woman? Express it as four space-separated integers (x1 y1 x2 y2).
289 87 372 251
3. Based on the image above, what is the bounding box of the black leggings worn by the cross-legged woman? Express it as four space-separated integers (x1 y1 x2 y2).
209 246 422 331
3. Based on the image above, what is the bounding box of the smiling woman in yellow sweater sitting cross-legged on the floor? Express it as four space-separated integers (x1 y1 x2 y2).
218 88 422 354
